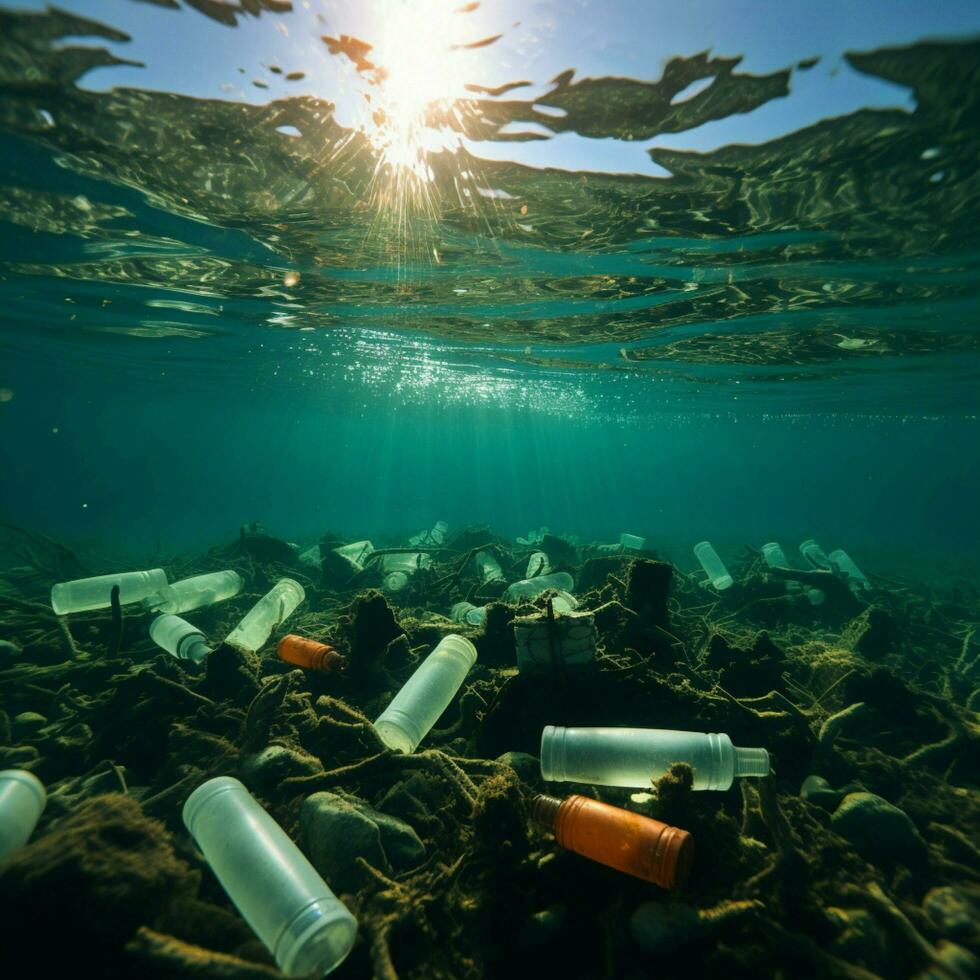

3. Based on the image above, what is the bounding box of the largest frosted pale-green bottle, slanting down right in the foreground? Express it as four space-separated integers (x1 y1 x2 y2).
183 776 357 976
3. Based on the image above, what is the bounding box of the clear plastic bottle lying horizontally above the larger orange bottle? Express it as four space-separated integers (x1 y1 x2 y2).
541 725 769 789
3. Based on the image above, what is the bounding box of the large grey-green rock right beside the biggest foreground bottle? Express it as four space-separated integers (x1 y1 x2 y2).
300 792 425 892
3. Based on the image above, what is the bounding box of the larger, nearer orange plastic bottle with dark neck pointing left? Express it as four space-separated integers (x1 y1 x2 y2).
531 795 694 888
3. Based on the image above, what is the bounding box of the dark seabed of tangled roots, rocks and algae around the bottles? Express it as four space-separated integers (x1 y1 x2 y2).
0 525 980 980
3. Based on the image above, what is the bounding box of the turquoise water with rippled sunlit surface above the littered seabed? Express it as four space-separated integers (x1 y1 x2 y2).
0 3 980 564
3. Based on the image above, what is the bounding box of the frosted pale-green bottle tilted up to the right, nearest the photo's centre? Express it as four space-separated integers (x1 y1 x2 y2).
374 633 476 752
